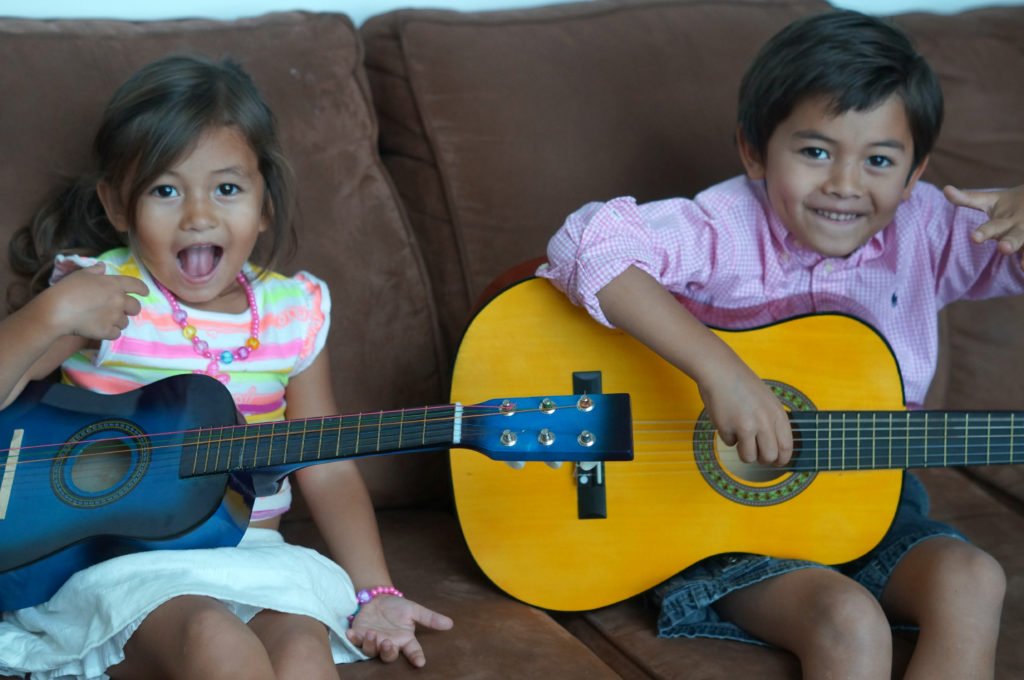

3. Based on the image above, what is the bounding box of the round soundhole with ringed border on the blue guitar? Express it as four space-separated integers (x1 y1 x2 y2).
50 420 152 509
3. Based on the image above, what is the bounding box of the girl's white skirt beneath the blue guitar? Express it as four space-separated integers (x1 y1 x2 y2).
0 528 366 680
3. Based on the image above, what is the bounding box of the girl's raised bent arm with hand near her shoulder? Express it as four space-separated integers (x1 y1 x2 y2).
0 264 147 409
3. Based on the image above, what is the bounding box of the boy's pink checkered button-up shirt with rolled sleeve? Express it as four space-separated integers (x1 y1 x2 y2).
538 177 1024 408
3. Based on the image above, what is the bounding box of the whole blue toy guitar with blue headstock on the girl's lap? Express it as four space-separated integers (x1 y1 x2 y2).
0 375 633 610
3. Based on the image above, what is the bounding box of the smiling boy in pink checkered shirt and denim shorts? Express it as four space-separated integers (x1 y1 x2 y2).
540 11 1024 680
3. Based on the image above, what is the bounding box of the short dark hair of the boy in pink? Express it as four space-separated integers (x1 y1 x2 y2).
738 10 942 170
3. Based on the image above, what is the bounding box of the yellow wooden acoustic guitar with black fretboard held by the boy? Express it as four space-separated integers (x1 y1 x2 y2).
451 279 1024 610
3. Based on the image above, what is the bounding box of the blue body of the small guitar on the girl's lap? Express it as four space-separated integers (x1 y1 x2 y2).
0 376 254 610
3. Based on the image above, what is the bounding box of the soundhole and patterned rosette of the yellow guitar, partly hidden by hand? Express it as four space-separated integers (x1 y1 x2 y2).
693 380 816 506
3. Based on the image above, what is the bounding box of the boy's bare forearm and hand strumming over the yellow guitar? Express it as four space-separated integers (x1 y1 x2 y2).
597 266 793 465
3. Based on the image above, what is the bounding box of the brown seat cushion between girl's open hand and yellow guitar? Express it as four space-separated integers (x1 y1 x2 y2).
282 510 621 680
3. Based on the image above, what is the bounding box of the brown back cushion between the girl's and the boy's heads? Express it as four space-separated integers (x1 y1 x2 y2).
360 0 827 356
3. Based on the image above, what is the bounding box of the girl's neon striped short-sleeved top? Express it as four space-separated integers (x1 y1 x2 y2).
50 248 331 521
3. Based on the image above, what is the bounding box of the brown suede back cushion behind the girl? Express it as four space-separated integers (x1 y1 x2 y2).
0 12 445 504
